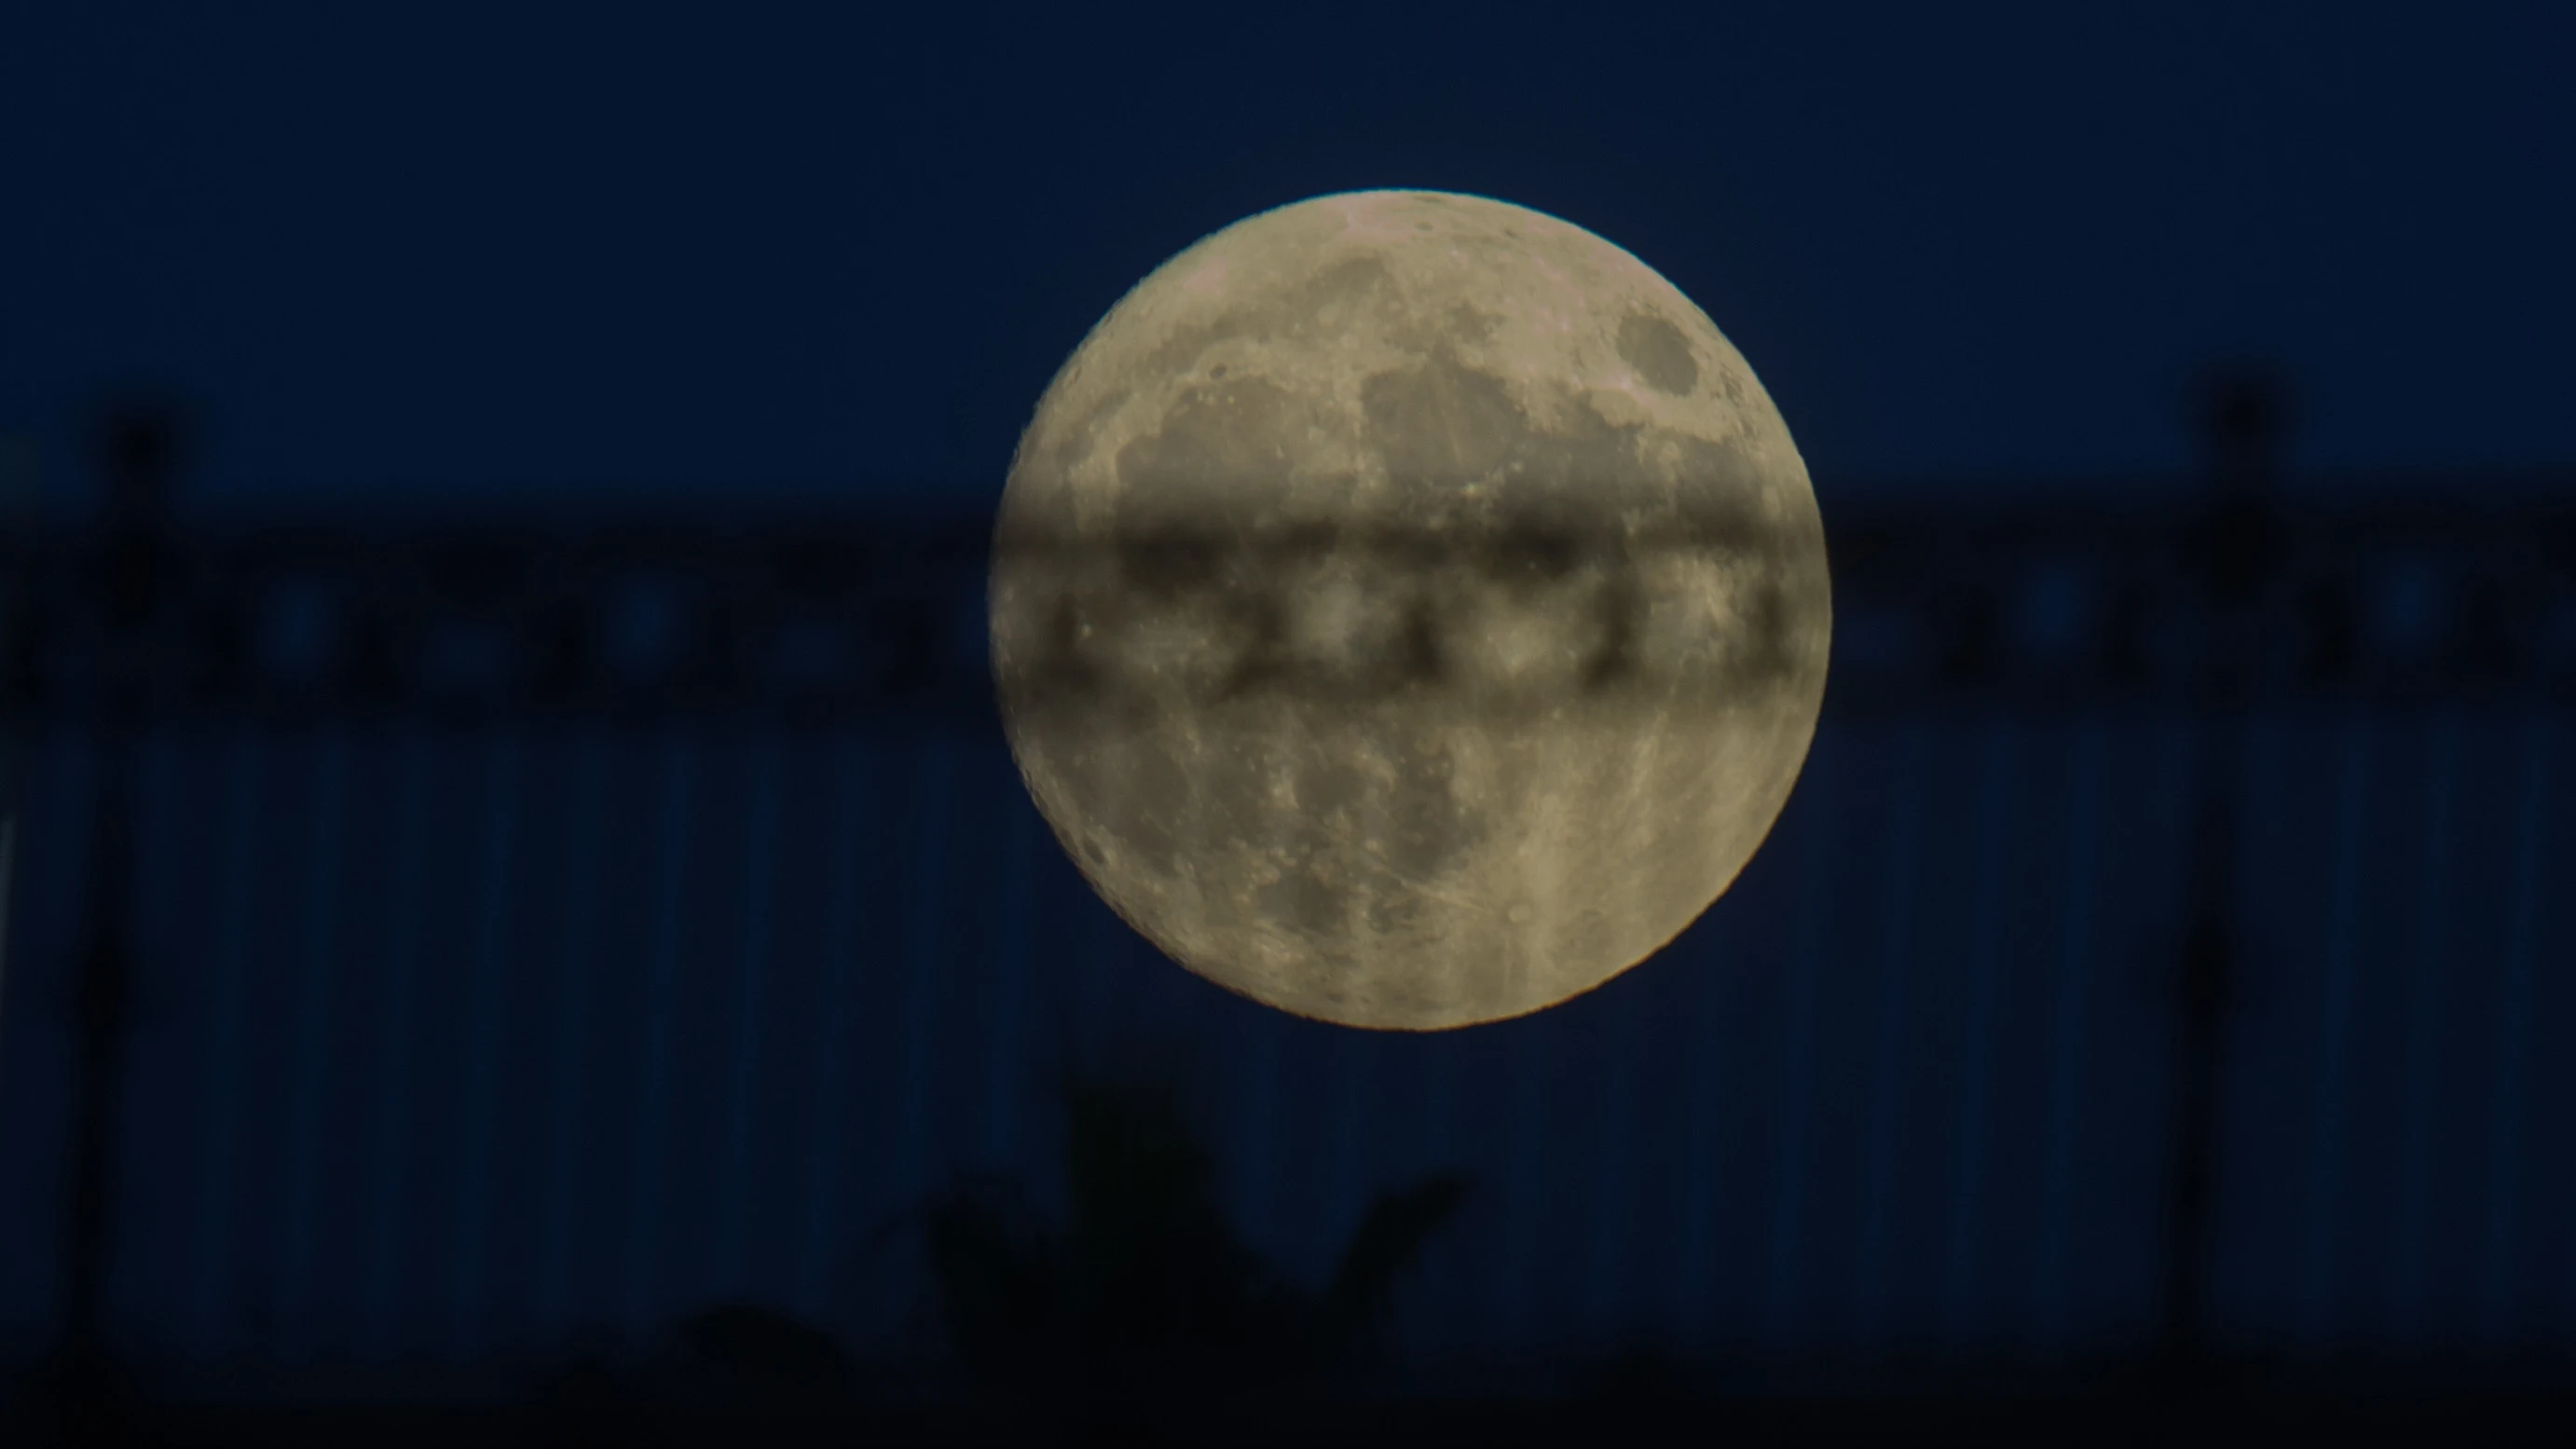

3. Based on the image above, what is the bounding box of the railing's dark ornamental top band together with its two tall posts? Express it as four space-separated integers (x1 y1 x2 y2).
0 399 2576 1389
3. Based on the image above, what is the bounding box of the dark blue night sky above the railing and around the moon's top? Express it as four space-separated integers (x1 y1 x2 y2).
0 0 2576 504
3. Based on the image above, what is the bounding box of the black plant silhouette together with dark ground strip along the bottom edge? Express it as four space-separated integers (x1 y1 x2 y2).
15 1081 2576 1449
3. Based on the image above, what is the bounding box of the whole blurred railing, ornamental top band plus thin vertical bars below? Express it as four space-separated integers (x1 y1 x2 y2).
0 414 2576 1410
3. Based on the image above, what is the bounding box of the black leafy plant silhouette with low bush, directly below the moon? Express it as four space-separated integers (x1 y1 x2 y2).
525 1076 1468 1443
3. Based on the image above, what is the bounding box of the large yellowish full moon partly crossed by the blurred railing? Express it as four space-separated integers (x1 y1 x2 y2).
992 190 1831 1030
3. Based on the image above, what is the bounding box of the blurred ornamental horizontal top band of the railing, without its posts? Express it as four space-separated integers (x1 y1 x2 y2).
0 486 2576 720
